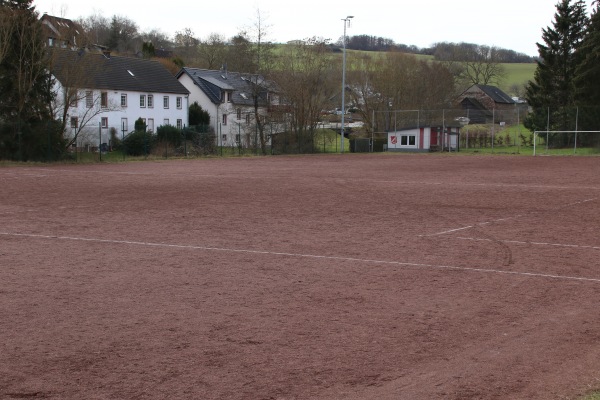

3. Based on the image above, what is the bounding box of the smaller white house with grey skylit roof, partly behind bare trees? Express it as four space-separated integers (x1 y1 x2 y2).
177 67 279 147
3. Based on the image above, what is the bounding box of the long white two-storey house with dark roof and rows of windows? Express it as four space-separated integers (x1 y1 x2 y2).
51 49 189 147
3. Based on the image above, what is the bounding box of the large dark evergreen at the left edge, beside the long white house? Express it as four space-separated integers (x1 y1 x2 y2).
0 0 61 160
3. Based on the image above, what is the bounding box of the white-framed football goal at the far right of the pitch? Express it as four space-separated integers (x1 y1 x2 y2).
533 131 600 156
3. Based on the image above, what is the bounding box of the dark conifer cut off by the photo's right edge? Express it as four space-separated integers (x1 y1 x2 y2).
575 2 600 130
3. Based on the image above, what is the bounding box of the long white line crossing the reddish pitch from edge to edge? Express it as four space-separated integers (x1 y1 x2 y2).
0 232 600 283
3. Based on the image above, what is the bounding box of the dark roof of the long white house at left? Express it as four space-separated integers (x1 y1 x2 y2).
51 50 189 94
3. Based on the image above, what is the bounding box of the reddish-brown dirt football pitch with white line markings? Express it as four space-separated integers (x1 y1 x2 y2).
0 155 600 400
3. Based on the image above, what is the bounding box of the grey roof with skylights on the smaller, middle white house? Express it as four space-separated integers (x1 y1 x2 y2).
177 67 267 106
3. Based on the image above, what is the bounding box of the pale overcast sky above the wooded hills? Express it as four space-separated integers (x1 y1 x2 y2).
33 0 592 56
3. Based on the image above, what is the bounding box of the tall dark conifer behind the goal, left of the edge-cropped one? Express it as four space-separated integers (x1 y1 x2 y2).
524 0 588 138
